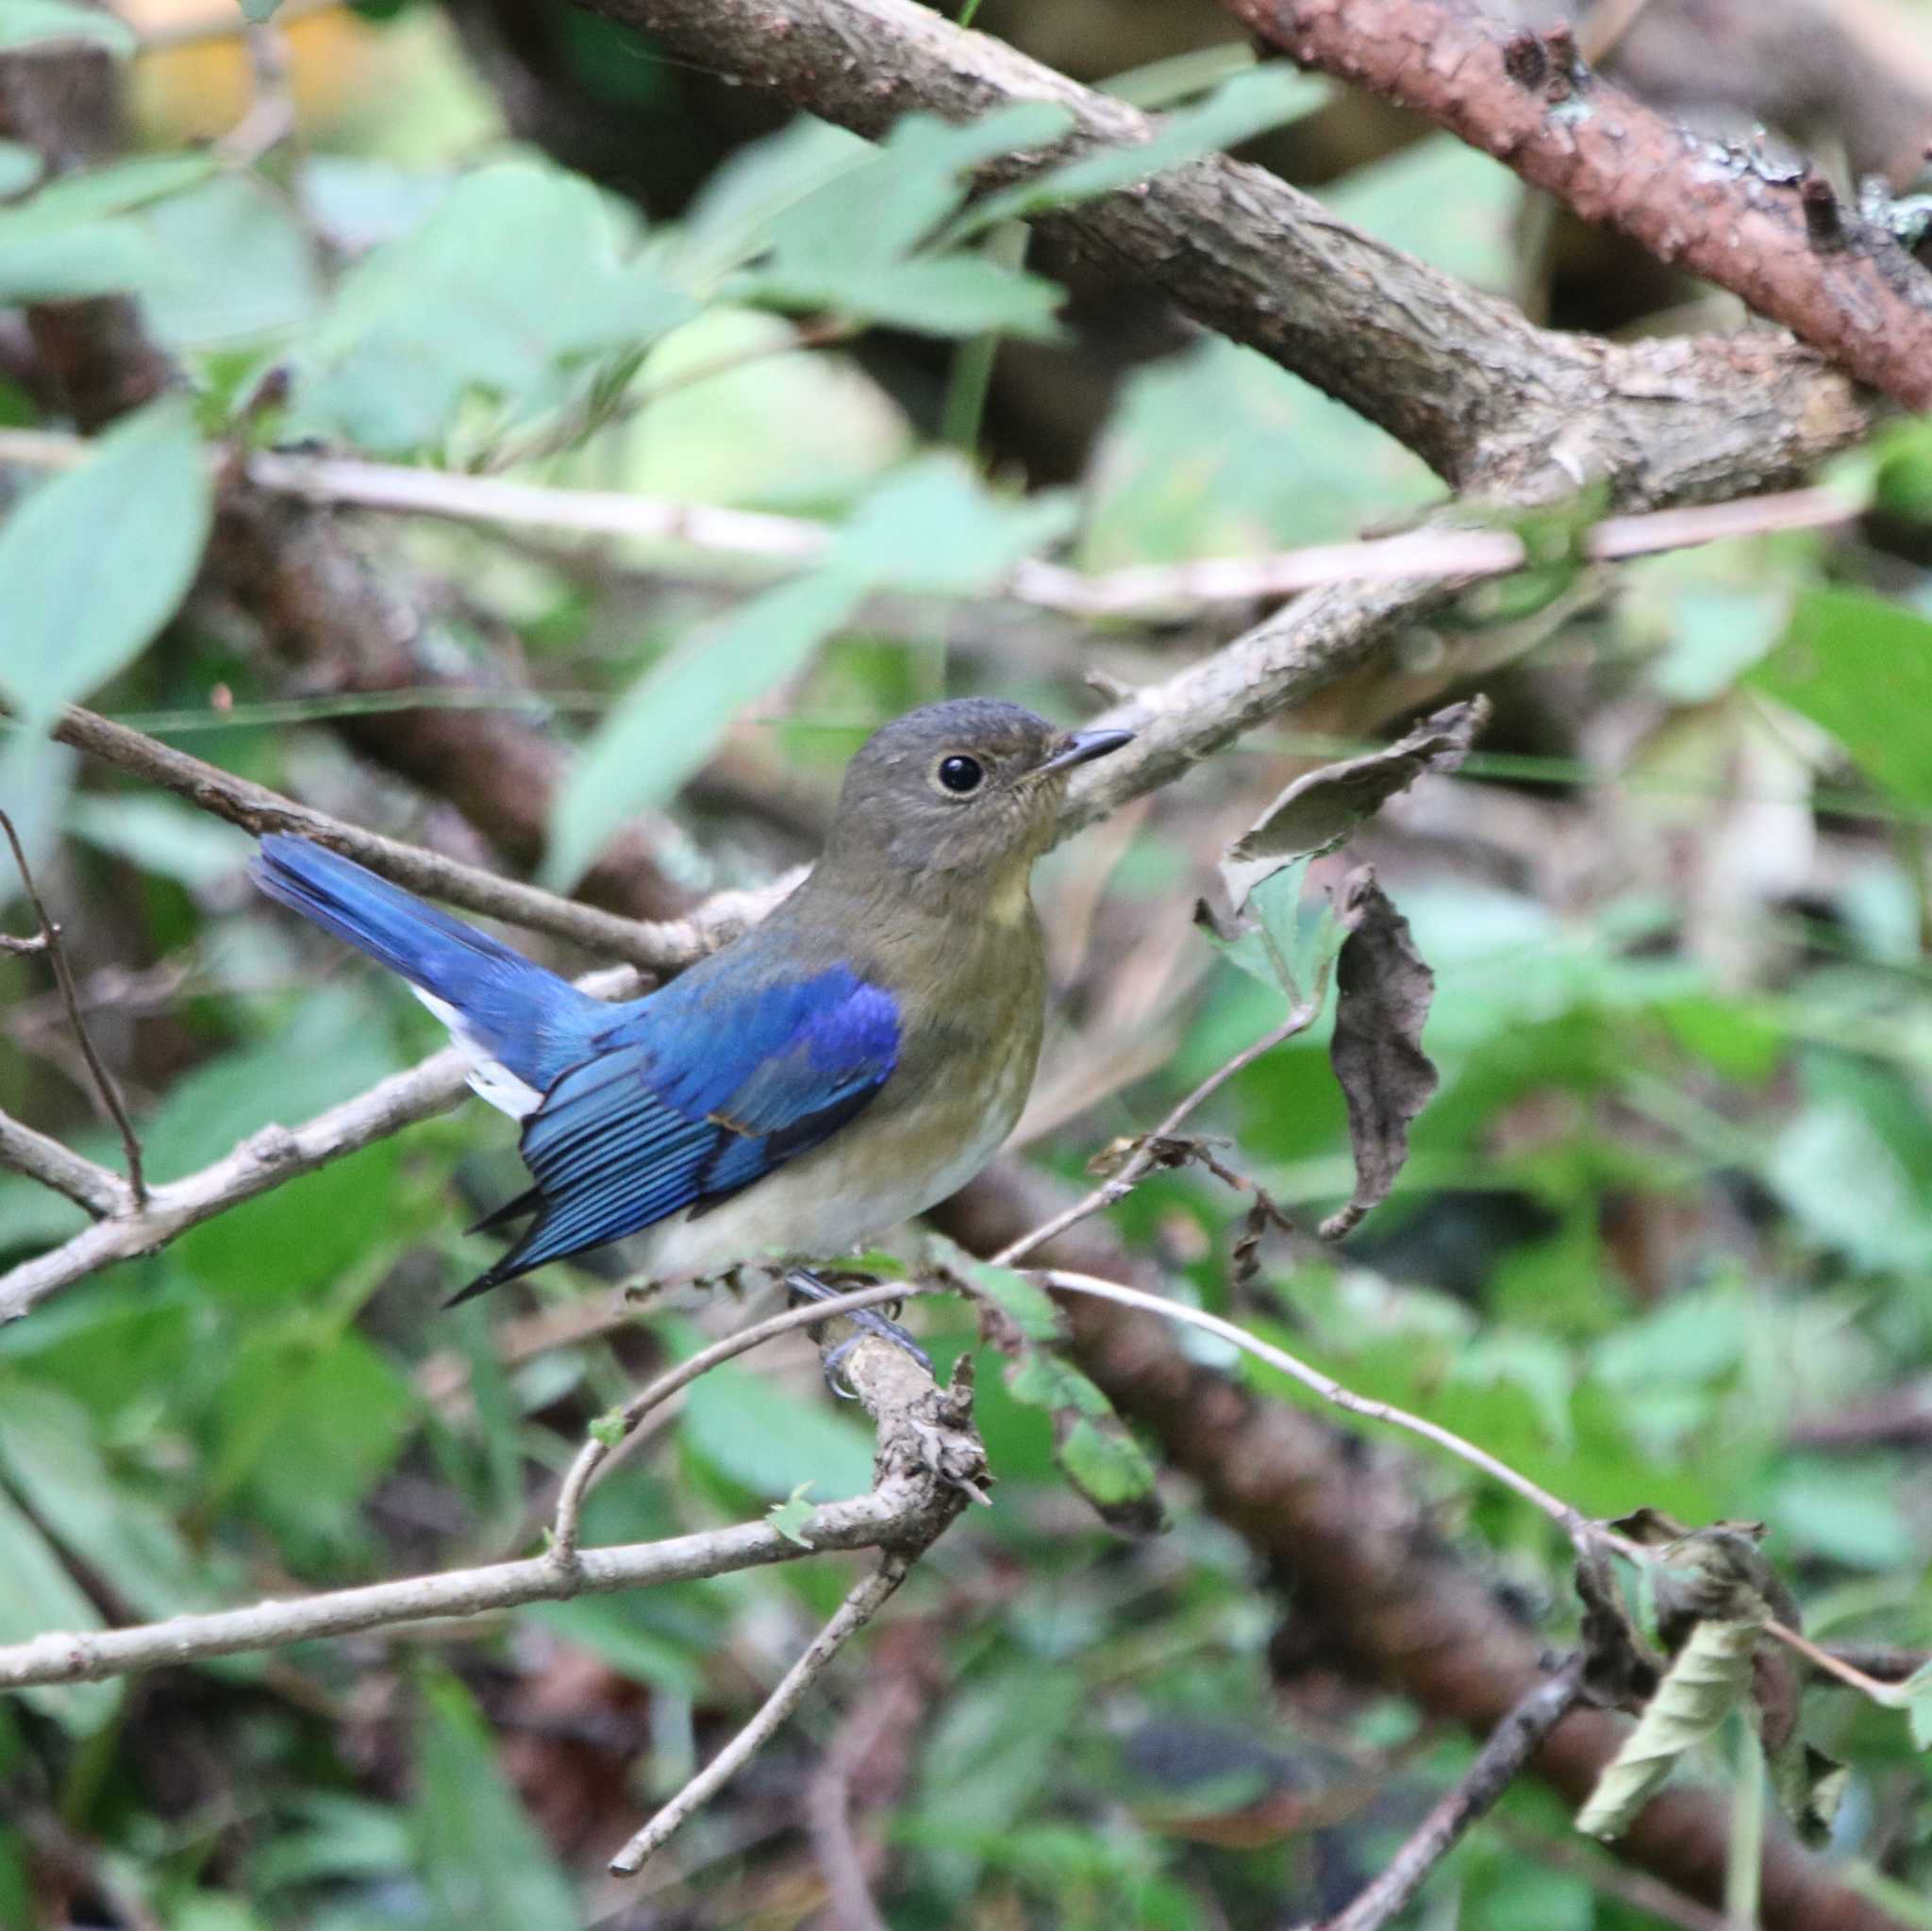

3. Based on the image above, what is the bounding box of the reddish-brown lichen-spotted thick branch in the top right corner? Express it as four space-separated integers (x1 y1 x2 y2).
1221 0 1932 409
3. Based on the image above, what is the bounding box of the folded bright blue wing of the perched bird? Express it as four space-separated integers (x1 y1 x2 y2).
458 961 898 1300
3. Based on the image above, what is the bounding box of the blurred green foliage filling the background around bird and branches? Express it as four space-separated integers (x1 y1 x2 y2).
0 0 1932 1931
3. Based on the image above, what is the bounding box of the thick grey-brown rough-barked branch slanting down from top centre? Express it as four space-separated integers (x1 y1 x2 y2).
579 0 1868 508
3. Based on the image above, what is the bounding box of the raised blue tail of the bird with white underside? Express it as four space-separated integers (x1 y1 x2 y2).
253 832 610 1112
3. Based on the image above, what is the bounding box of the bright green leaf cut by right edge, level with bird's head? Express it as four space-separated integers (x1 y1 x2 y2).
1744 589 1932 809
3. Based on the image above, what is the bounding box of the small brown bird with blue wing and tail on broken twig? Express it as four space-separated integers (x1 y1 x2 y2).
255 697 1132 1300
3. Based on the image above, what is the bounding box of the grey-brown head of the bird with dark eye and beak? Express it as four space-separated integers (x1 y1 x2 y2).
824 697 1134 892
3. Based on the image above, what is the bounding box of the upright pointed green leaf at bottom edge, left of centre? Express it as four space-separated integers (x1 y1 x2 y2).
411 1671 583 1931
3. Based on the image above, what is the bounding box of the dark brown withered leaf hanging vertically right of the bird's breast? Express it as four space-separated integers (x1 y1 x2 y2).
1322 865 1436 1240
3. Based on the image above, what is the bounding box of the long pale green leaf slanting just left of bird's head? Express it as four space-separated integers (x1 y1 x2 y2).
542 570 866 891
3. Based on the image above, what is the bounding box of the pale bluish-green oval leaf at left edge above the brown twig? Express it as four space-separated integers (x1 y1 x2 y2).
0 398 212 730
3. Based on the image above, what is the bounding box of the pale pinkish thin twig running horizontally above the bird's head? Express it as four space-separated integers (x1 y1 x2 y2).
0 428 1858 618
